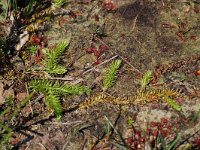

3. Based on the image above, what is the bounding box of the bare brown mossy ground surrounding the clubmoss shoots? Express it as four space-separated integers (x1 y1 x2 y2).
2 0 200 150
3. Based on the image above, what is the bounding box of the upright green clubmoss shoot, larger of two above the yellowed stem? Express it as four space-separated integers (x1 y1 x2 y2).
103 59 122 91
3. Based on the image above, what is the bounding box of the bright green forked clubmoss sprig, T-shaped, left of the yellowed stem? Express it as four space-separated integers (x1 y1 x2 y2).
30 79 90 118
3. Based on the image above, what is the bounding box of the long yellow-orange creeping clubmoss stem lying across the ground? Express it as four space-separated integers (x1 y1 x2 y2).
79 88 180 110
